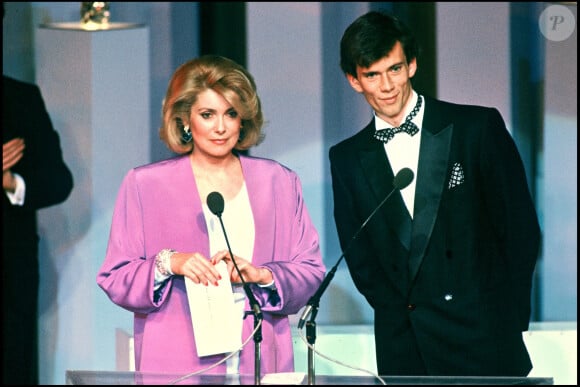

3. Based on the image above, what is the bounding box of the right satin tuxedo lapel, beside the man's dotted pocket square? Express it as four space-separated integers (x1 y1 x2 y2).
409 125 453 282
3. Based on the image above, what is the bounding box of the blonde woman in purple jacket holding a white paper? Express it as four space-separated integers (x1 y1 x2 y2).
97 55 325 374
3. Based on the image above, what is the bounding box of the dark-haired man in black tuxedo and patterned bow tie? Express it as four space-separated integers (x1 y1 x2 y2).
329 11 541 376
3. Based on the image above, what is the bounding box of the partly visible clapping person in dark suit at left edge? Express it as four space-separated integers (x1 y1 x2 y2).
2 3 73 385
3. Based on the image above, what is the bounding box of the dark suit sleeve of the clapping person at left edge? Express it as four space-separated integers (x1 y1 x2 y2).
9 83 73 210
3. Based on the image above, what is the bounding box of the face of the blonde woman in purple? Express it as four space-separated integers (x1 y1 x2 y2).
189 89 242 158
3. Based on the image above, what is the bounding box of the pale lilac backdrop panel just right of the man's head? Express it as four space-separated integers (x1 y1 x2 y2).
436 2 511 130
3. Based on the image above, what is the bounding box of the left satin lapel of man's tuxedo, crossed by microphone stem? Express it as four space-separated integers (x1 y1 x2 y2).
360 144 412 250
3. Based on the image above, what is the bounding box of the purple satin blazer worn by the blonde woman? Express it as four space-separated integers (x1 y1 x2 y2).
97 155 325 374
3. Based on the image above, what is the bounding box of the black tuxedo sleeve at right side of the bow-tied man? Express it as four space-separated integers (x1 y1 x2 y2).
480 109 541 331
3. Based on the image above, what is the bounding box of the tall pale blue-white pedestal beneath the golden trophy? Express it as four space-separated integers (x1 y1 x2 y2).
36 23 150 384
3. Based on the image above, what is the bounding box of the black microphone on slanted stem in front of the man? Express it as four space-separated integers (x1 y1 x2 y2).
298 168 414 329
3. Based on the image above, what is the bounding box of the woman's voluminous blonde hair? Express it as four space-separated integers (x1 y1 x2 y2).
159 55 264 154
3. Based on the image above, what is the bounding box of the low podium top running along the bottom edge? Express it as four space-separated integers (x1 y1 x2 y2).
66 371 554 386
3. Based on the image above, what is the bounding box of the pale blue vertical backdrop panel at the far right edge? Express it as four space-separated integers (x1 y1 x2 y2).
538 4 578 321
